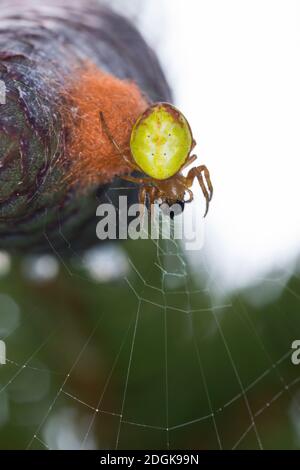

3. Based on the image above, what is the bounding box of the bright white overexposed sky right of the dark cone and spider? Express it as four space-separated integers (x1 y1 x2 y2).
138 0 300 289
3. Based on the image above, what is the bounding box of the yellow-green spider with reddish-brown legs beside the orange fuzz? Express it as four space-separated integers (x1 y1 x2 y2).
100 102 213 217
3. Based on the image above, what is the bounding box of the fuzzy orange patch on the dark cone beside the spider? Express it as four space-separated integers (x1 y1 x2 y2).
61 64 148 189
